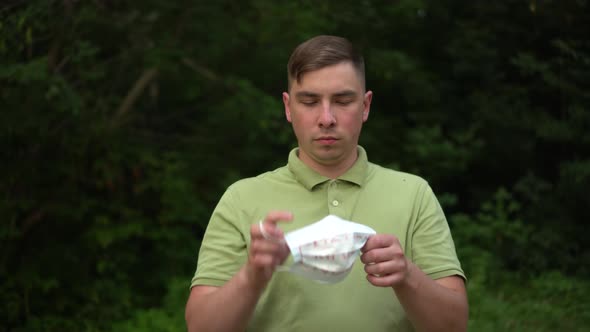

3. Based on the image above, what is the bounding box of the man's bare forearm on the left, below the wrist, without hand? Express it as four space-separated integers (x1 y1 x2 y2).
186 268 264 332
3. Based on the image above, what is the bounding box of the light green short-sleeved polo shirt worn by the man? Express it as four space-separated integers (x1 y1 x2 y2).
191 146 464 332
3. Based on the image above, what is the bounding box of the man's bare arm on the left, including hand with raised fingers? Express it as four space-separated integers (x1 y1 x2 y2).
185 211 292 332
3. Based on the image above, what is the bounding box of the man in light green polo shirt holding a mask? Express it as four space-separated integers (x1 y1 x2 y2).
186 36 468 332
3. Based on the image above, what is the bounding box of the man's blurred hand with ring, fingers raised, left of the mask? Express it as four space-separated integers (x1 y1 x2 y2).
246 211 293 287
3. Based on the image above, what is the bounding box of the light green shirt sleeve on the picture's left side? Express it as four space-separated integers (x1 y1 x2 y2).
191 187 249 287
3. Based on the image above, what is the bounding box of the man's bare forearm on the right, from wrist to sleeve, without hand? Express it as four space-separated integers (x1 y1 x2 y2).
394 263 469 331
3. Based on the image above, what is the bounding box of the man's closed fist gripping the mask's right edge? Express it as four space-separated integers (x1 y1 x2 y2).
361 234 410 287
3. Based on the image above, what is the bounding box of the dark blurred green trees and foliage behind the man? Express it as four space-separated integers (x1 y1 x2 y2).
0 0 590 332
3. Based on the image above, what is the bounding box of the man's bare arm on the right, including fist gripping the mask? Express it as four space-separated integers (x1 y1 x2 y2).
361 234 468 332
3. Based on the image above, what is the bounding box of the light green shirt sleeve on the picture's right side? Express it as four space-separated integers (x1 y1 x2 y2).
412 183 465 279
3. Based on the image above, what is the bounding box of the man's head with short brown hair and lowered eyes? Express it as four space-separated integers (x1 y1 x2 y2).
283 36 373 178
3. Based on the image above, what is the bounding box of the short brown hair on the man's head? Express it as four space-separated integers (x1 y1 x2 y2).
287 35 365 91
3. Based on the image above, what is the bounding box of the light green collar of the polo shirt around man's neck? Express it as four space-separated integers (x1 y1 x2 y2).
288 145 369 190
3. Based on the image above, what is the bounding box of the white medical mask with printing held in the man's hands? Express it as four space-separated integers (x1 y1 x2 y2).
279 215 376 283
